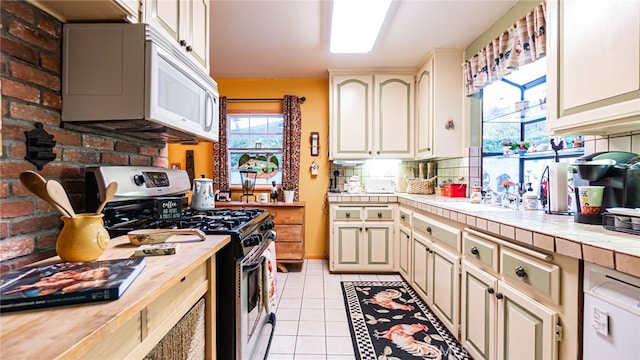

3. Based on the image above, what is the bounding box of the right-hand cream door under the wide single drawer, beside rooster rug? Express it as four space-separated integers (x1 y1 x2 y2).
427 243 460 338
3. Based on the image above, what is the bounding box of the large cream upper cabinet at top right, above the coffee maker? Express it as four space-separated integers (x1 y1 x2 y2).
547 0 640 134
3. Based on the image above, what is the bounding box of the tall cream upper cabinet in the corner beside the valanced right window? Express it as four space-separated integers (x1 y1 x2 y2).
415 49 465 159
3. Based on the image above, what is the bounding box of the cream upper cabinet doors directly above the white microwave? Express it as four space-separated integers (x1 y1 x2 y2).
144 0 210 72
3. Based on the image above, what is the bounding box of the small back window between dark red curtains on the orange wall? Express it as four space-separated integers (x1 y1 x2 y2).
227 113 284 186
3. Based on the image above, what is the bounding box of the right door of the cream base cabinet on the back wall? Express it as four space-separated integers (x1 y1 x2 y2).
363 223 393 271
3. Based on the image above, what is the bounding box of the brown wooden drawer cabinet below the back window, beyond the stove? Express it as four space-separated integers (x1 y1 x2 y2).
216 201 305 272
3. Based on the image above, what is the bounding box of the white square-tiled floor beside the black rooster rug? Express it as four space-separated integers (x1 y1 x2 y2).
269 259 402 360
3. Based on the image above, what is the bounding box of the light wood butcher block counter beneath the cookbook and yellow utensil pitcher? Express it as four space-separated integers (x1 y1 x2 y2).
0 235 229 359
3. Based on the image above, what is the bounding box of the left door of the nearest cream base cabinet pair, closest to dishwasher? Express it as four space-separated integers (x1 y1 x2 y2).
460 261 498 360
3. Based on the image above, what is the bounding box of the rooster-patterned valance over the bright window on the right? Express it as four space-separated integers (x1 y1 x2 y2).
462 1 547 95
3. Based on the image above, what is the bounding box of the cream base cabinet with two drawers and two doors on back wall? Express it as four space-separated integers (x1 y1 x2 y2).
329 204 395 272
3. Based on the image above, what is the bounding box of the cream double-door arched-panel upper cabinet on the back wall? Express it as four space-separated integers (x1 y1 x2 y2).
329 72 415 160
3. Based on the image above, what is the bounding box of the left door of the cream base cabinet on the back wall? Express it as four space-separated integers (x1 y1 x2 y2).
331 223 362 271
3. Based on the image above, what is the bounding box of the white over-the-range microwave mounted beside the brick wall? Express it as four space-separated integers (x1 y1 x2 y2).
62 23 219 142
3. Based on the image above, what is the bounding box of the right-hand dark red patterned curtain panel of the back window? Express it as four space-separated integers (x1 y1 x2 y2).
282 95 302 201
